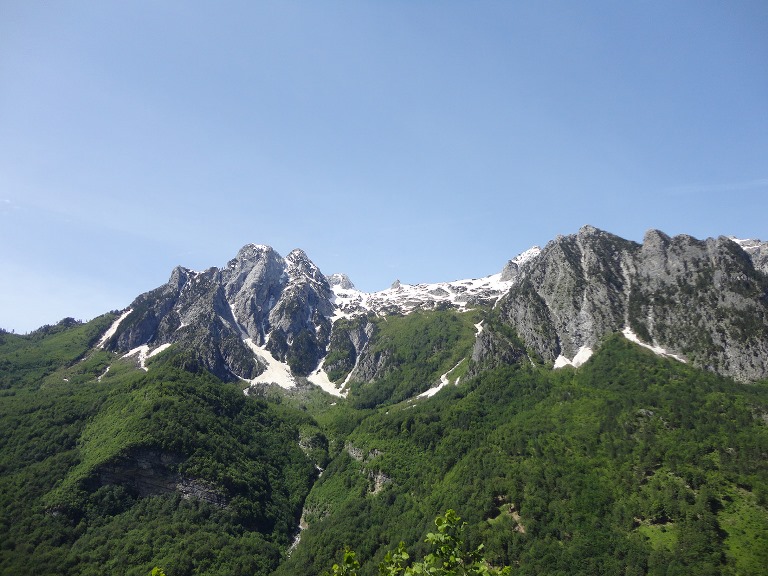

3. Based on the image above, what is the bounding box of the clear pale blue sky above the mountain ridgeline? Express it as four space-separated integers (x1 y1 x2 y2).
0 0 768 332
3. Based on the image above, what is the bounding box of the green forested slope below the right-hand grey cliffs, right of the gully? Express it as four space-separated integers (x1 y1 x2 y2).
278 335 768 575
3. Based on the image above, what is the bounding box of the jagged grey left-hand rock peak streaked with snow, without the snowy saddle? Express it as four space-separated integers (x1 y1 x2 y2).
106 244 333 380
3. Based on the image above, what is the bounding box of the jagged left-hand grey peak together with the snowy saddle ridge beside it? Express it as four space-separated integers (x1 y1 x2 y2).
102 244 538 394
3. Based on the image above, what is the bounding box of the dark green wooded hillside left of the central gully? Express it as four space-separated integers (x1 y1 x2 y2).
0 320 326 576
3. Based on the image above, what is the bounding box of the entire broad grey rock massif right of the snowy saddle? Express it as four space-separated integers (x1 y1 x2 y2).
498 226 768 381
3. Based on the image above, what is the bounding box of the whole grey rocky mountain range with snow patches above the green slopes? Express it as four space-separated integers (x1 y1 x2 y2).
101 226 768 394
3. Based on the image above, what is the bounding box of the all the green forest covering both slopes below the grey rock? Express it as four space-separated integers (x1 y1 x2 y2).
0 312 768 576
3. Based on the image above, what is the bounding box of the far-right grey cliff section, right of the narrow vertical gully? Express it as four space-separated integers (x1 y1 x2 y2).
629 231 768 381
